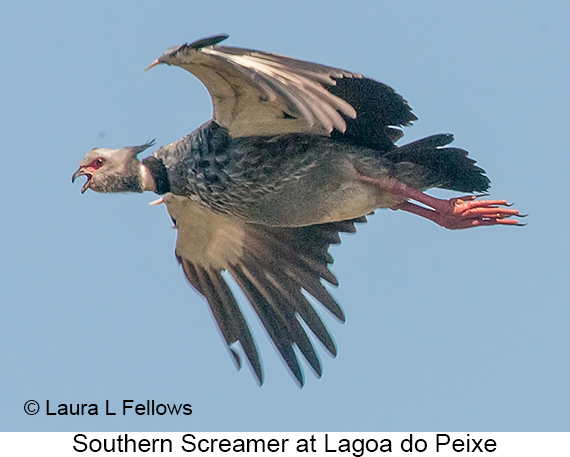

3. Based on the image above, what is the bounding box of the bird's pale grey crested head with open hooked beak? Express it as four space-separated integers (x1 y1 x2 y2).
71 140 154 193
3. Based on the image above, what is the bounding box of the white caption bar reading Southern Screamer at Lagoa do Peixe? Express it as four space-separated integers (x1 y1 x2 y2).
0 432 570 457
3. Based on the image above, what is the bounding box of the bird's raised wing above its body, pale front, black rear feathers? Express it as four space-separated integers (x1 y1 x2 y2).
149 35 416 143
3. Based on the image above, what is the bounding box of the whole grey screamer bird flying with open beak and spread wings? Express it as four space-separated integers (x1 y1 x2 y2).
72 35 519 386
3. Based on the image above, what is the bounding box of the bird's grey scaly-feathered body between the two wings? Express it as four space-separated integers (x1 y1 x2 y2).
154 123 397 227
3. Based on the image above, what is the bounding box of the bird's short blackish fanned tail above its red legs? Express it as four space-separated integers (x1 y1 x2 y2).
384 134 490 192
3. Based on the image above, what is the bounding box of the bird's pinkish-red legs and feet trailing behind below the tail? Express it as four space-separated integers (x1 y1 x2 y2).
360 176 520 230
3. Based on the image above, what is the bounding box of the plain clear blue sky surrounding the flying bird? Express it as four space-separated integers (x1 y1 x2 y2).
0 0 570 431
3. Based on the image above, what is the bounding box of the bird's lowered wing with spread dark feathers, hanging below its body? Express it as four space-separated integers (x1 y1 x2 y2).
163 194 366 385
